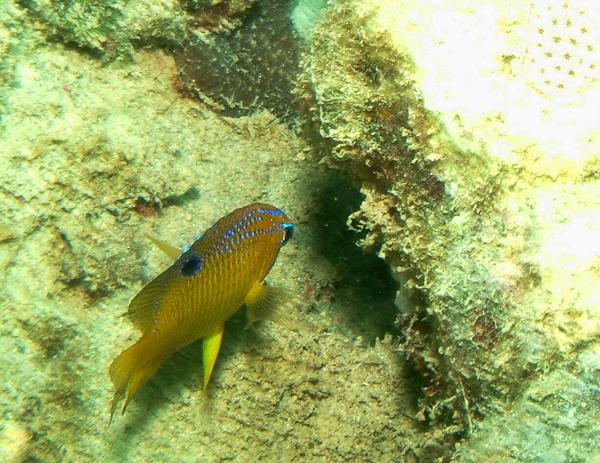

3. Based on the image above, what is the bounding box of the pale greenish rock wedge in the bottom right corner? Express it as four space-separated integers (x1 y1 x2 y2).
456 345 600 463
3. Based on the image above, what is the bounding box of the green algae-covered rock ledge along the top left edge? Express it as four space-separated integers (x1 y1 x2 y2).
15 0 255 58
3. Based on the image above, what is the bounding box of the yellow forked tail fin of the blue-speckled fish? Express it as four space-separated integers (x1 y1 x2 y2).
109 337 166 425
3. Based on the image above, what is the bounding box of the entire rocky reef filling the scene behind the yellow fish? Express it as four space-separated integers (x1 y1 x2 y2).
0 0 600 462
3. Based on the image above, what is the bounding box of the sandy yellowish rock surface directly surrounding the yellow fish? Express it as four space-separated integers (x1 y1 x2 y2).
0 1 419 462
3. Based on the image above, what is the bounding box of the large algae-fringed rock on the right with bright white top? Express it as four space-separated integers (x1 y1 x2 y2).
304 0 600 461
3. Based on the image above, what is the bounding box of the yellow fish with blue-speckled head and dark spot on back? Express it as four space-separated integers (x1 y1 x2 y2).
109 203 294 420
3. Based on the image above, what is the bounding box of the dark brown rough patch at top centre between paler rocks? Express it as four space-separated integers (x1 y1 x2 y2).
175 0 299 119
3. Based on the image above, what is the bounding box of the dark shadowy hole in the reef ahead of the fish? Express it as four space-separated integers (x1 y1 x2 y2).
312 170 399 341
